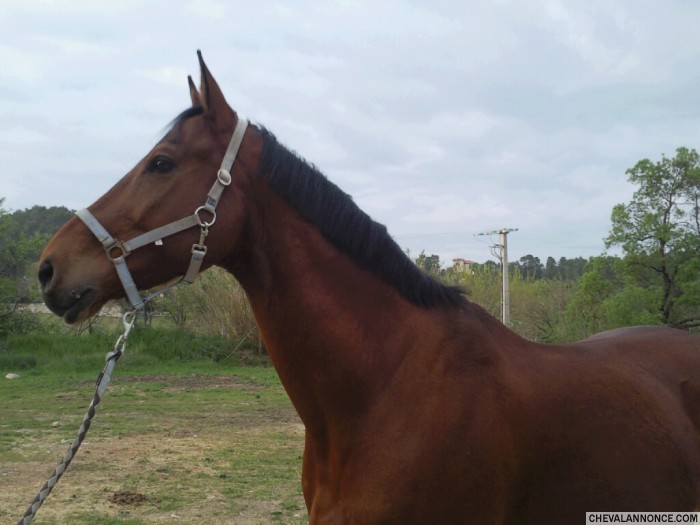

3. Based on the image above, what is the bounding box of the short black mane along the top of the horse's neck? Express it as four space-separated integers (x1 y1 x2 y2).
257 127 467 307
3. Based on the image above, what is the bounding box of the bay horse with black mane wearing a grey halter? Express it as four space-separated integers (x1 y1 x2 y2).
39 53 700 525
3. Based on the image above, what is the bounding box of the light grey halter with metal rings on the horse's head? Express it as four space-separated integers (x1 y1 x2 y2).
76 119 248 310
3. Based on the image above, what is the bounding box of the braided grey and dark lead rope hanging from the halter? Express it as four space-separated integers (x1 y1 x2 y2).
17 310 137 525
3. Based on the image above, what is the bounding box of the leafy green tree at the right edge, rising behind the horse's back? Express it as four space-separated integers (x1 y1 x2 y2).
605 148 700 328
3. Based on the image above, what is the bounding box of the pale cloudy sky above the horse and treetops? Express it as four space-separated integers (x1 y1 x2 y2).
0 0 700 264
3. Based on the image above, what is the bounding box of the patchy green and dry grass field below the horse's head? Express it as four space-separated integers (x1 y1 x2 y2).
0 328 306 525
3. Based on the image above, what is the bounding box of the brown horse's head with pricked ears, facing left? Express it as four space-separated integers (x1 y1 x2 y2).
39 53 250 323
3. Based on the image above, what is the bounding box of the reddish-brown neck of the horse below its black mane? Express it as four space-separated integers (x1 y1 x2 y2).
229 182 434 434
